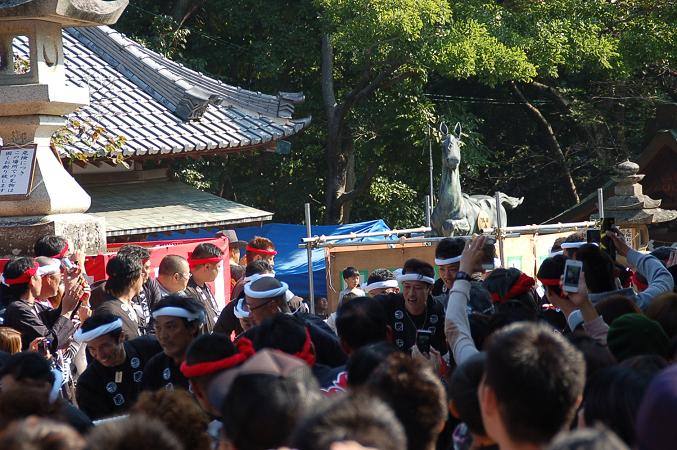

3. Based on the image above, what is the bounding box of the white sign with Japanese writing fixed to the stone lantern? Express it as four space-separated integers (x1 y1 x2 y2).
0 144 37 200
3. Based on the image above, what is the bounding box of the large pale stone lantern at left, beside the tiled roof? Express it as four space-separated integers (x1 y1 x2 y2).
0 0 128 256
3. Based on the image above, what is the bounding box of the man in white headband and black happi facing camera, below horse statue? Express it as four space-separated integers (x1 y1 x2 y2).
378 258 447 354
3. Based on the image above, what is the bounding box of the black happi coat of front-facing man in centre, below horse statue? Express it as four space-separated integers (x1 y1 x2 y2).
376 294 447 355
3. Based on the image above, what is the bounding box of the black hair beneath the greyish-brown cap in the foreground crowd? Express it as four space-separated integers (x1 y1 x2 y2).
221 372 319 450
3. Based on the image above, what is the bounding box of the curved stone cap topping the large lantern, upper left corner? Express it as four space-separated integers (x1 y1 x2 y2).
0 0 129 27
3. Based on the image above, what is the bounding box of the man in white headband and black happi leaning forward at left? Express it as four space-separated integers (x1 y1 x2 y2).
74 314 162 420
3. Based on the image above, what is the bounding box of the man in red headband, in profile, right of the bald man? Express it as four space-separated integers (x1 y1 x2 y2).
185 244 223 333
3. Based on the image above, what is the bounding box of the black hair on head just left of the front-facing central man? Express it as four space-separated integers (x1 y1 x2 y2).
336 297 388 350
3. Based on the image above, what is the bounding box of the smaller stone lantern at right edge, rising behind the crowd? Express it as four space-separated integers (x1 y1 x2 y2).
592 161 677 249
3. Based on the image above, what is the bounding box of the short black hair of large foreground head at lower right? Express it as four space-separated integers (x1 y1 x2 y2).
484 323 585 444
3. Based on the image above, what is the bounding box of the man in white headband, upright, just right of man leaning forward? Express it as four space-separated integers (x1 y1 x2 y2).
143 294 206 391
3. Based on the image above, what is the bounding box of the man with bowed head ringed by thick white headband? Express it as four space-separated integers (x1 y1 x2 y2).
244 277 346 367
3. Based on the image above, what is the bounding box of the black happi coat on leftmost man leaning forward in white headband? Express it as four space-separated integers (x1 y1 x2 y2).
75 336 162 420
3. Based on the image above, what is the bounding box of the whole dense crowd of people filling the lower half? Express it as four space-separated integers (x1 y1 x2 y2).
0 230 677 450
